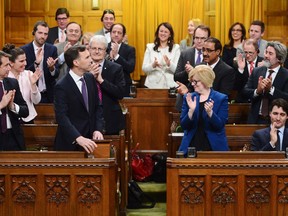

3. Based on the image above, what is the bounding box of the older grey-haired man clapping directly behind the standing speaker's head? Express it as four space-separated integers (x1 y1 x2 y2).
55 22 82 80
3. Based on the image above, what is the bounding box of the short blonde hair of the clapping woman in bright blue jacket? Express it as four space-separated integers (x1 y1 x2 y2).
189 65 215 88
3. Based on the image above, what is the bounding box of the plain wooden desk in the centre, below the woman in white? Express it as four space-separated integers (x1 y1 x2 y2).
121 88 176 151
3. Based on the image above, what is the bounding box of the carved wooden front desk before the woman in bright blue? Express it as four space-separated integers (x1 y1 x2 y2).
167 152 288 216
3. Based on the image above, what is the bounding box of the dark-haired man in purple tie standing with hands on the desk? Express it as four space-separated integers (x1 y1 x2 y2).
54 45 103 153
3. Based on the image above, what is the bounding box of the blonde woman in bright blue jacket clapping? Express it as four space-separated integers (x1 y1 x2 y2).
179 65 229 155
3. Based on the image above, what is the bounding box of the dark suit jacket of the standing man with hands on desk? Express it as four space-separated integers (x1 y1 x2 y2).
54 73 103 151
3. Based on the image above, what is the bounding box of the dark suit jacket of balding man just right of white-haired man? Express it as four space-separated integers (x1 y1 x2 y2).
107 43 136 97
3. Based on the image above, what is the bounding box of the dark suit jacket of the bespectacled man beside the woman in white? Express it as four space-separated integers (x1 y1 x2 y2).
174 47 195 86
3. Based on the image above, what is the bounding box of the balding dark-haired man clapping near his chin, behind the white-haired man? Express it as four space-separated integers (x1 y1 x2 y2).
107 23 136 97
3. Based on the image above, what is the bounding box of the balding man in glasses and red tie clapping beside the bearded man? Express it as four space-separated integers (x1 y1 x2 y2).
234 39 263 103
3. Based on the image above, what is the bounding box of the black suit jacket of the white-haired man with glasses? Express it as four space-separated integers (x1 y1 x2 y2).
101 60 125 134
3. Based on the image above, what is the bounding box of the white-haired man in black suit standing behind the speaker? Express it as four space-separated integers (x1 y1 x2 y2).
89 35 125 134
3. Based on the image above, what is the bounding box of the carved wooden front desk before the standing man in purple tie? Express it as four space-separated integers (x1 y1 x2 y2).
0 152 118 216
